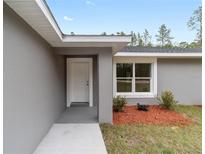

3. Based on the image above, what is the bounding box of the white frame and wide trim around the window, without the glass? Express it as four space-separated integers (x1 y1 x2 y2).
113 57 157 98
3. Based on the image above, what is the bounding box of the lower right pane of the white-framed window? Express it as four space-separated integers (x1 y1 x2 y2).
135 79 150 92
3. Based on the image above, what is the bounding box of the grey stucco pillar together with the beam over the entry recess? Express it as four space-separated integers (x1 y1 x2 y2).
54 47 113 123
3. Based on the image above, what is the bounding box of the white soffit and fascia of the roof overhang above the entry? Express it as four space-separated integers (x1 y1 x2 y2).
4 0 131 51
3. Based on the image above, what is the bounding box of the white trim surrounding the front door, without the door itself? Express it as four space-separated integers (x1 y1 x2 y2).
66 58 93 107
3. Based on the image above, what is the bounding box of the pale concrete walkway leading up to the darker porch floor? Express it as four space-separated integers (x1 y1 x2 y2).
34 123 107 154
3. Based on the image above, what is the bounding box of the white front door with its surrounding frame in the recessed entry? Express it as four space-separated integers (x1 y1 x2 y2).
67 58 92 106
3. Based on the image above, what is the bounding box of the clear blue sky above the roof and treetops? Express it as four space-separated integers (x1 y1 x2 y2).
46 0 201 42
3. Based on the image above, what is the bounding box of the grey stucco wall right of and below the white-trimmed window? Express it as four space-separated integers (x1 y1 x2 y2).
125 58 202 105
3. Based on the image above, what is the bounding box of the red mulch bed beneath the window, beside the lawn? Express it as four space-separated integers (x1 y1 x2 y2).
113 105 192 125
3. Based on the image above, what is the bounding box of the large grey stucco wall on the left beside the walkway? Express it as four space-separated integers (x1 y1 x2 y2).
3 4 65 154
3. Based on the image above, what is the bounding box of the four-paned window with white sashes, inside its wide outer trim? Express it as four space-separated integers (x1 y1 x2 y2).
114 57 156 96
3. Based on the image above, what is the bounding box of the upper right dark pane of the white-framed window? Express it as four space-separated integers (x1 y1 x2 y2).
135 64 151 77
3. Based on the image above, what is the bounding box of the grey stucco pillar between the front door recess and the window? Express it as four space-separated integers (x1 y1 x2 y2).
98 50 113 123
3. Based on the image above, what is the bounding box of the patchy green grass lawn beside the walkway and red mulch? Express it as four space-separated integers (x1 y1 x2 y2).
100 106 202 154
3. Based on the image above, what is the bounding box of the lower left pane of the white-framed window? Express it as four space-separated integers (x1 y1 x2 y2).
117 79 132 92
